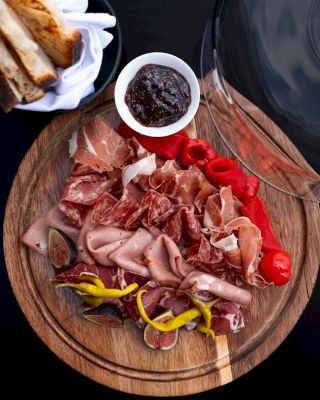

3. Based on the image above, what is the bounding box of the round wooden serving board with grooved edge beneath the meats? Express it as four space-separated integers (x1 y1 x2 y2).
4 85 320 396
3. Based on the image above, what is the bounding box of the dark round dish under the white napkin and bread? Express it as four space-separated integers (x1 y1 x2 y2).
64 0 122 112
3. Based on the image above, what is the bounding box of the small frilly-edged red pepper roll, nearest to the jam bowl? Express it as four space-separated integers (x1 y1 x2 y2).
180 139 217 170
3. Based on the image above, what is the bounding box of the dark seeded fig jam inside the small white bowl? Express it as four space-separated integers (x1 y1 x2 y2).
125 64 191 127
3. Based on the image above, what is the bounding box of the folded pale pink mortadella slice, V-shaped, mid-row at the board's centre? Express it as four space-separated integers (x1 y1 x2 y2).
109 228 153 277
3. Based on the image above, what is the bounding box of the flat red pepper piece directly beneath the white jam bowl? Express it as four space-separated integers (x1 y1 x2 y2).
118 122 188 160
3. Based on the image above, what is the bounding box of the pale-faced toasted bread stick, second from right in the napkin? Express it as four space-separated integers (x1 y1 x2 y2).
0 0 58 87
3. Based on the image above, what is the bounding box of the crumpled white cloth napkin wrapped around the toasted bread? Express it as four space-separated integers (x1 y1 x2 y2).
16 0 116 111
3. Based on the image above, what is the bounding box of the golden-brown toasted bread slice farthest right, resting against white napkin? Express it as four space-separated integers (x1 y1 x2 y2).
7 0 82 68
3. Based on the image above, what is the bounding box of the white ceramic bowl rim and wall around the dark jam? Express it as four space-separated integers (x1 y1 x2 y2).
114 53 200 137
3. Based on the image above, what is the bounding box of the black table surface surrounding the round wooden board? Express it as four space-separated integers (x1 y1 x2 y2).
0 0 320 399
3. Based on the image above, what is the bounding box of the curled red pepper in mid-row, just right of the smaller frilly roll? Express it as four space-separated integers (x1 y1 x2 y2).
205 157 246 199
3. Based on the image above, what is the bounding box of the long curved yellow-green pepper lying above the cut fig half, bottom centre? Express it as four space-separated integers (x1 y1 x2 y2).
137 290 201 332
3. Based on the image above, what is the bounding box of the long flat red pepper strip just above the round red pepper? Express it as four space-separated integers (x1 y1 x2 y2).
240 197 282 253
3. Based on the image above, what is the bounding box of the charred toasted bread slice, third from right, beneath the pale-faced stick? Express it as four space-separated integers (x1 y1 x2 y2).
0 37 44 103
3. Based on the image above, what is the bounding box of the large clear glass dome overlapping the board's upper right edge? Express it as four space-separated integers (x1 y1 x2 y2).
201 0 320 201
